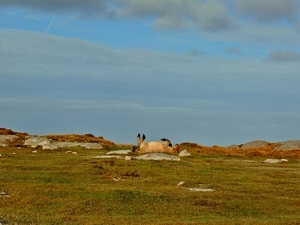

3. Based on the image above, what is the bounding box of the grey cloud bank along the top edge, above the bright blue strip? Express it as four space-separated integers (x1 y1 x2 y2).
0 0 300 32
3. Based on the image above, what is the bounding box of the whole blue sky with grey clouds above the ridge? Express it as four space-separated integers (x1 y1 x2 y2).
0 0 300 146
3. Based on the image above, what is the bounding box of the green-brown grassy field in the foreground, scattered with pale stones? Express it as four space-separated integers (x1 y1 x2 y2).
0 147 300 225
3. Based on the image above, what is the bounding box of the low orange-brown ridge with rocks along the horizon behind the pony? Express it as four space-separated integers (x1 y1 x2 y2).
0 128 300 159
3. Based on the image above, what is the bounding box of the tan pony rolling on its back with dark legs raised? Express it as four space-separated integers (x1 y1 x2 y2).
137 134 179 153
